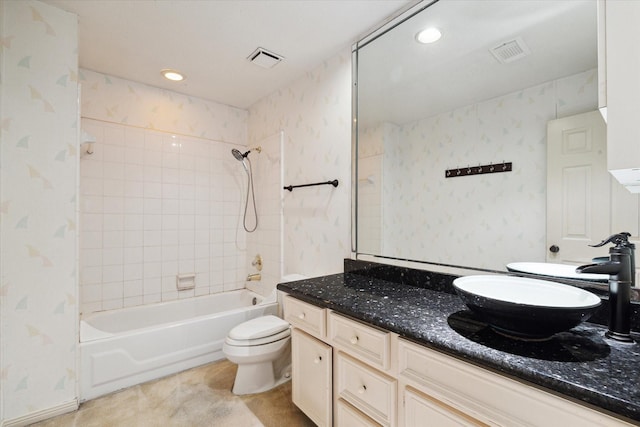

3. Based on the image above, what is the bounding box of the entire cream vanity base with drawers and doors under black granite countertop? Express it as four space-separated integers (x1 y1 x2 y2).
283 295 632 427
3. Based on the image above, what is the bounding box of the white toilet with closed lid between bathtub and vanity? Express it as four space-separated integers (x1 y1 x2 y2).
222 315 291 394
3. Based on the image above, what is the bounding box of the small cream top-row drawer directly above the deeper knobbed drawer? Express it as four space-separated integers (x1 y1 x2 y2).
327 312 391 370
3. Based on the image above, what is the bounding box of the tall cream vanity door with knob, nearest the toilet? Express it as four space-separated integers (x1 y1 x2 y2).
291 328 333 427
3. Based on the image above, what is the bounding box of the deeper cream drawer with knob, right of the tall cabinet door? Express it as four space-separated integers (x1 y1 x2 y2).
335 352 397 426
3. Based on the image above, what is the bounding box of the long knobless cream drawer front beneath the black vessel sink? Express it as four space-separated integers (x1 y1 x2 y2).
398 339 631 427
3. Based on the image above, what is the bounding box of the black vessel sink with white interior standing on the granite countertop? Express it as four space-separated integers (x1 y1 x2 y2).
453 275 600 340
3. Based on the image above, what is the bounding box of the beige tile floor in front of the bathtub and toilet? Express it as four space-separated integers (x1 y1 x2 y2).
33 360 314 427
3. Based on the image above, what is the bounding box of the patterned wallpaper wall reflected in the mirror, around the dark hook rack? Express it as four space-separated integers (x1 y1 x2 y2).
380 70 597 269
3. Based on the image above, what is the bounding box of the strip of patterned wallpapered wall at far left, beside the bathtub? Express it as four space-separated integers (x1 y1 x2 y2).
0 0 78 420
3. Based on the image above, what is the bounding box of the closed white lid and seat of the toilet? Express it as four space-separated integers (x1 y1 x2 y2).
225 315 291 347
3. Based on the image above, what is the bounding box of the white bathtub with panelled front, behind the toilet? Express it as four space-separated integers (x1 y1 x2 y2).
80 289 278 401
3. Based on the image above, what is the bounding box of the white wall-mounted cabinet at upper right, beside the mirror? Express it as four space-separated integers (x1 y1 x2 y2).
598 0 640 189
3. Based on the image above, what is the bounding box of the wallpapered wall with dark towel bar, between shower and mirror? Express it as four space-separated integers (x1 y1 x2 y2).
249 51 351 276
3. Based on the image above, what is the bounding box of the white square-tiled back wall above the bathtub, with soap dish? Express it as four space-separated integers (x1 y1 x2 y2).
80 118 247 314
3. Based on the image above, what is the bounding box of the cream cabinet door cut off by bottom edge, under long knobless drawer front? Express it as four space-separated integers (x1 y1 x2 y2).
400 387 487 427
